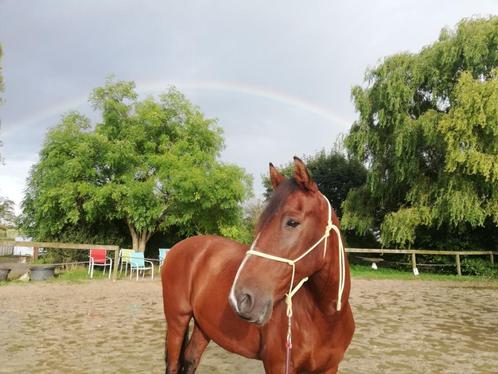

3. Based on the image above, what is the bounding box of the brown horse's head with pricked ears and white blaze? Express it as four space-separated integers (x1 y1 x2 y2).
229 157 332 324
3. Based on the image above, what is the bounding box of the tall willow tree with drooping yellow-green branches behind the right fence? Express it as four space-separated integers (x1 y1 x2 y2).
342 17 498 251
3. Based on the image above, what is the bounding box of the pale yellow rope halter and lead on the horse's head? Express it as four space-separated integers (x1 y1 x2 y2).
246 194 345 374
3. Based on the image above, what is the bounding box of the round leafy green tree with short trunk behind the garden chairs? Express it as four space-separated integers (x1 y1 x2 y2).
21 79 251 251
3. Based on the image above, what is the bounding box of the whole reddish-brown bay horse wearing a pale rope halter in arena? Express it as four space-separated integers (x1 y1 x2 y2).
161 157 355 374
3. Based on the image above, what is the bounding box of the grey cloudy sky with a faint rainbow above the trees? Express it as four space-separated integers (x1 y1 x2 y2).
0 0 498 213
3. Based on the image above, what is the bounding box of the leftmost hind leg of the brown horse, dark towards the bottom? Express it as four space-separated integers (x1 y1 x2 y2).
165 316 191 374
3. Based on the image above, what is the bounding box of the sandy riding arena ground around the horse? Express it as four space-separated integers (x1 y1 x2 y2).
0 279 498 374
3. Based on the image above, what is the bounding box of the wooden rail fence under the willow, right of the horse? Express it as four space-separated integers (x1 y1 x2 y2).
346 248 498 275
